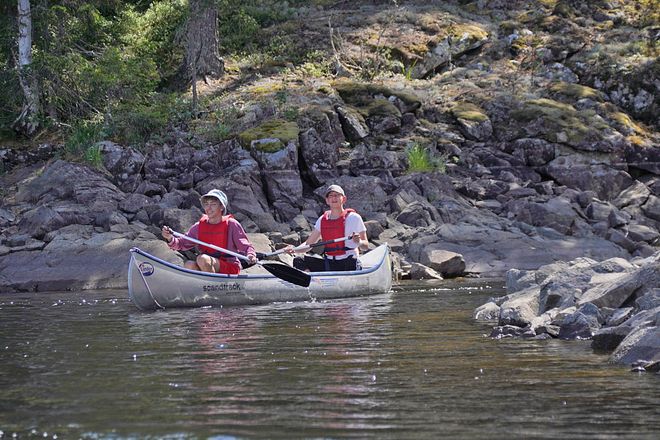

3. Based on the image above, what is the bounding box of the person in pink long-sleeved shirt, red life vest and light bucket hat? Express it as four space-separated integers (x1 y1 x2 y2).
161 189 257 274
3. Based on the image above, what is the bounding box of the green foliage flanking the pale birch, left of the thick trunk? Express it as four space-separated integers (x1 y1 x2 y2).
0 0 173 137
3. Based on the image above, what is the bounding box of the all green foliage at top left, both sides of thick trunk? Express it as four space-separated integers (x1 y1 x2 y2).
0 0 327 139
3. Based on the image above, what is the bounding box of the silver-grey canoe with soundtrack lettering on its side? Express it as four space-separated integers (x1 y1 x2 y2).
128 244 392 310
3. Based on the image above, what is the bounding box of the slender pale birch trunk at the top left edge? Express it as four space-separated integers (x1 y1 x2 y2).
12 0 39 137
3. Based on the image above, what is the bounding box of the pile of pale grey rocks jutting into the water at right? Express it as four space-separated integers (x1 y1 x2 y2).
474 252 660 373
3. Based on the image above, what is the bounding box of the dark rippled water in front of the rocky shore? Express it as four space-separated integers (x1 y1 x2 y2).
0 280 660 439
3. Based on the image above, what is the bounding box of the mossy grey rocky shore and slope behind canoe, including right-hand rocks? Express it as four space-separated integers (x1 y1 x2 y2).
0 2 660 368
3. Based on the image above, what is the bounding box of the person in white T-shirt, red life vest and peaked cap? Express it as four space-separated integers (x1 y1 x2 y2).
287 185 369 272
